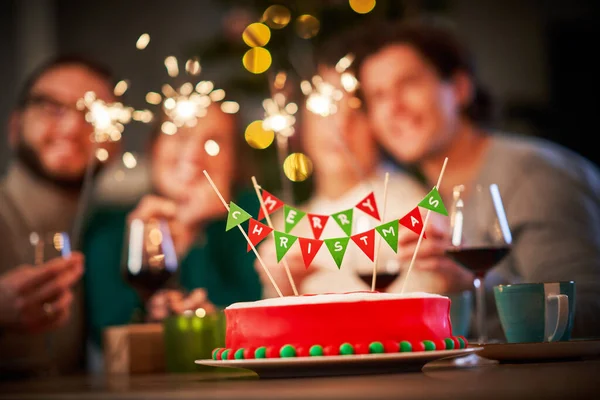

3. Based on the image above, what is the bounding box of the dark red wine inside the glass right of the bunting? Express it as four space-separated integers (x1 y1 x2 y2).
446 245 510 278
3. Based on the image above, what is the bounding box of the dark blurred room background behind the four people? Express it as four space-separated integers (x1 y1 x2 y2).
0 0 600 194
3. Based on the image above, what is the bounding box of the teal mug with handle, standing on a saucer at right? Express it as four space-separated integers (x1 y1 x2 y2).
494 281 575 343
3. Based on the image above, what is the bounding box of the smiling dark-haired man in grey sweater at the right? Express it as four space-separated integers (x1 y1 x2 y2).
353 20 600 338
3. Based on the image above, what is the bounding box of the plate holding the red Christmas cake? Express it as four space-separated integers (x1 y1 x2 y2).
196 347 482 378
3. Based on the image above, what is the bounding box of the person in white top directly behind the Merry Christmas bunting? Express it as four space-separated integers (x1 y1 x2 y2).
256 36 452 297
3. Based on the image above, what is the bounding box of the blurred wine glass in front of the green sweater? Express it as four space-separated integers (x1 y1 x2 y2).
122 219 178 310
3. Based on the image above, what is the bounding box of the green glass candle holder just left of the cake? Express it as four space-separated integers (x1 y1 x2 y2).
163 309 225 373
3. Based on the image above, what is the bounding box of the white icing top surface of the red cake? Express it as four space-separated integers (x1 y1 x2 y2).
226 292 447 310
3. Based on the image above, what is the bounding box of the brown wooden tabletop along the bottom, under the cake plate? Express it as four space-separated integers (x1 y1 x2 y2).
0 359 600 400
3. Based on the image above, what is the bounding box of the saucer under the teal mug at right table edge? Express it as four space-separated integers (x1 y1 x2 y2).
477 340 600 362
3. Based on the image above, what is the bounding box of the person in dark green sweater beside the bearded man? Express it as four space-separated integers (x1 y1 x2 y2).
83 103 262 347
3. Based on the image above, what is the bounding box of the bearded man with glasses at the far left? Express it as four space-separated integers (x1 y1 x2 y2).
0 56 115 377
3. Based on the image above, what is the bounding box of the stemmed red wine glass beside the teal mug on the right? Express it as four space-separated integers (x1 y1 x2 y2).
446 184 512 343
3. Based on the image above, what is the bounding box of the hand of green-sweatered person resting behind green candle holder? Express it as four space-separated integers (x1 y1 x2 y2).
146 289 216 322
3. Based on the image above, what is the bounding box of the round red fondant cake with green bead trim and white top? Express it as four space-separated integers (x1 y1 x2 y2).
213 292 467 359
